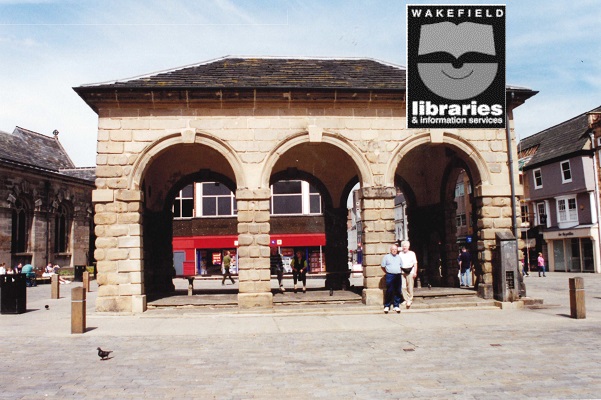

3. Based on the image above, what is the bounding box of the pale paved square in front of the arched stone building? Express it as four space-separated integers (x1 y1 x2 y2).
0 273 601 399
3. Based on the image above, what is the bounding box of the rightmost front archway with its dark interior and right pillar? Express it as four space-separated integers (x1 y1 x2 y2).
389 132 511 297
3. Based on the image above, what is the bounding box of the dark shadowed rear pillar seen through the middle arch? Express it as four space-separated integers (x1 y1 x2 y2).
324 207 350 290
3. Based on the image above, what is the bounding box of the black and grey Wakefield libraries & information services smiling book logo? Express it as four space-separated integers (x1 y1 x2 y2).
407 5 506 128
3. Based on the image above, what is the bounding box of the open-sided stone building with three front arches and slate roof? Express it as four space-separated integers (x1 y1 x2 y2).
75 57 536 312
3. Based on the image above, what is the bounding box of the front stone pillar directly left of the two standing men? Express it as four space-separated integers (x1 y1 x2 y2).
359 187 396 306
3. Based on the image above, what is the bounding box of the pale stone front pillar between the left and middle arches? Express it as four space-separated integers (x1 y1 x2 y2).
236 189 273 308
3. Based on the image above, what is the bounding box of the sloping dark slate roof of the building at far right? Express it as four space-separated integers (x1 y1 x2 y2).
518 106 601 169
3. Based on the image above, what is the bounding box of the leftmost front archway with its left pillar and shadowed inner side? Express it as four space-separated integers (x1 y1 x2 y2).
94 131 244 312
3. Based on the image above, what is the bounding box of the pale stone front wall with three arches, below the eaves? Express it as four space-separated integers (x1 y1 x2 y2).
93 100 515 311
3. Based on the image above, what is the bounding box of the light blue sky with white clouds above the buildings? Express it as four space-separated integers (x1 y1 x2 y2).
0 0 601 166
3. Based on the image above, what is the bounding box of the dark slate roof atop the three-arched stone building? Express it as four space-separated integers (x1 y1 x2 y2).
76 56 405 90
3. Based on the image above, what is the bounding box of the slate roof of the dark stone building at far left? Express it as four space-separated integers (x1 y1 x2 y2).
0 126 95 180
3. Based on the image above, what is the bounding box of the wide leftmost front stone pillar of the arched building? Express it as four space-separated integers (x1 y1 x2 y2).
92 188 144 312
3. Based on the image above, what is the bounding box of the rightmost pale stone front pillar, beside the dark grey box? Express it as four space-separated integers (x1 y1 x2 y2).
474 196 511 299
